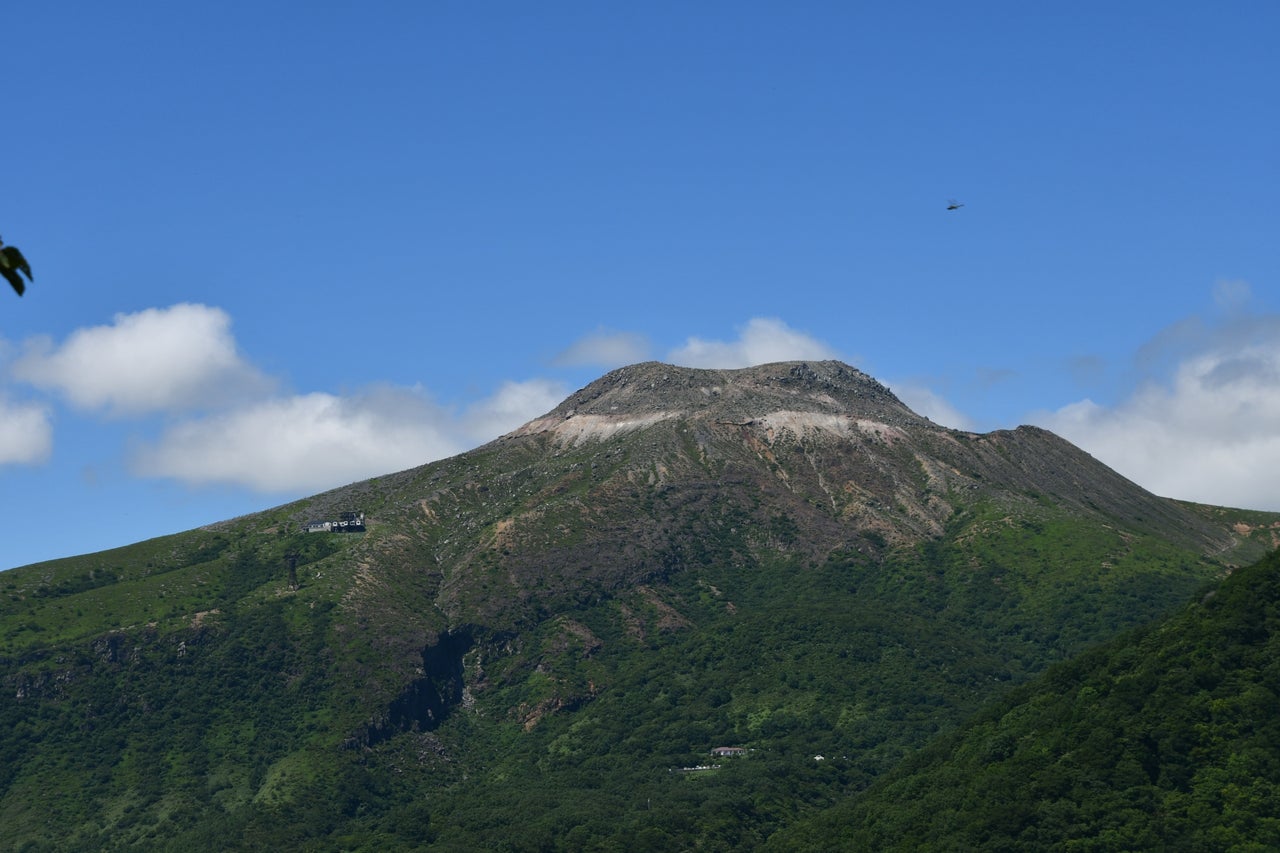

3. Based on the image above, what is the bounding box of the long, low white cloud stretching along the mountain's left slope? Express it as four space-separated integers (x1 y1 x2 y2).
132 380 561 492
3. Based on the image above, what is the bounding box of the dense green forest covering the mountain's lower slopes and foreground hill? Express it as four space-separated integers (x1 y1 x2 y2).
0 494 1276 850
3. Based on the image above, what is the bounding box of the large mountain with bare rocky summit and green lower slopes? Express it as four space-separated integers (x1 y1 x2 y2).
0 361 1280 850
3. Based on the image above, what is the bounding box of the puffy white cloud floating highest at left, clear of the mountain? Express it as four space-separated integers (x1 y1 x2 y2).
12 304 270 415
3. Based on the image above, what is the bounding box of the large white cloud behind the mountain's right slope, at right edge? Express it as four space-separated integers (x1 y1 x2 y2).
1034 338 1280 510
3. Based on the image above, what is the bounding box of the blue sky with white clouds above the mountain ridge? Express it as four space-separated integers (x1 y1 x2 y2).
0 0 1280 567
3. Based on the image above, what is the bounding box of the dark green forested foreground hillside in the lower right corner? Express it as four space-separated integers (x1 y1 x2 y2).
771 545 1280 850
